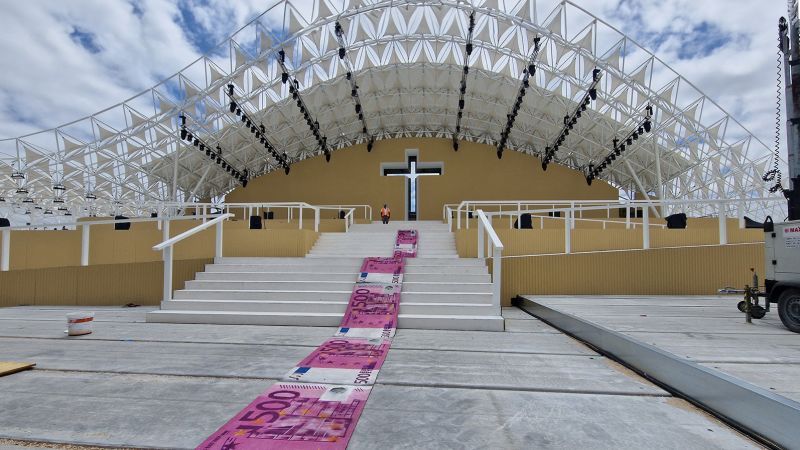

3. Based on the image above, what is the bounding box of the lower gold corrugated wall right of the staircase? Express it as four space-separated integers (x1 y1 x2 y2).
496 244 764 305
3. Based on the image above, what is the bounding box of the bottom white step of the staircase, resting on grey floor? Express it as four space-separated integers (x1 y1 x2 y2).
147 310 504 331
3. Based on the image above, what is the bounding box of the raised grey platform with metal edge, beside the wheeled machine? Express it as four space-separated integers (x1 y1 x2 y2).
516 295 800 442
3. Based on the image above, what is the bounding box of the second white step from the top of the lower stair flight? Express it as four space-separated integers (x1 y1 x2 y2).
205 264 487 276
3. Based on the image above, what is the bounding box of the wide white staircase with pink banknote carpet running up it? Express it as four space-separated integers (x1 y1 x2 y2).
147 221 503 331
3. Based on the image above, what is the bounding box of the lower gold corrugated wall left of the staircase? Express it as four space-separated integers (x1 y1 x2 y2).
0 258 212 306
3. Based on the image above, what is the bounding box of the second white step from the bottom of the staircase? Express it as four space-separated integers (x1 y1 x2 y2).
161 299 492 317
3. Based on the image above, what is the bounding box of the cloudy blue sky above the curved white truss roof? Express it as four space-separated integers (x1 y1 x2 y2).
0 0 786 153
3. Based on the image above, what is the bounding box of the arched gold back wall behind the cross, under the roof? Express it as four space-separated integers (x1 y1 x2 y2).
226 138 619 220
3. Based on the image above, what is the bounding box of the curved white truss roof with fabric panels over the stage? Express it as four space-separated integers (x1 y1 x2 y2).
0 0 788 220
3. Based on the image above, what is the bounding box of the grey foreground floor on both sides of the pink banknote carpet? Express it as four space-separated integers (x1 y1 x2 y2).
0 306 760 449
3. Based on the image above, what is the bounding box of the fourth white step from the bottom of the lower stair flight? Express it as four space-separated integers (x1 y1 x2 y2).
186 279 492 293
